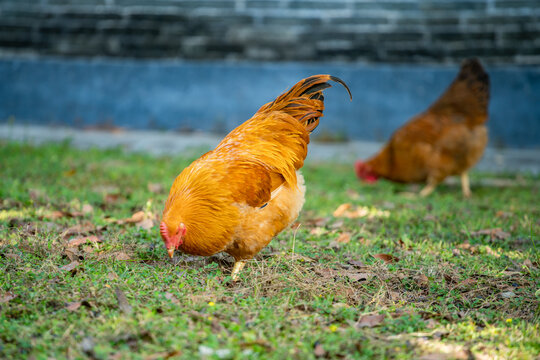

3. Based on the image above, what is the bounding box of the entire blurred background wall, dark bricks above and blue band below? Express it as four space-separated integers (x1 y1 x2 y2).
0 0 540 147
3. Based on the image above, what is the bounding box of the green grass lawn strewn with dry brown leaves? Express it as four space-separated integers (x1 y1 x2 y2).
0 142 540 360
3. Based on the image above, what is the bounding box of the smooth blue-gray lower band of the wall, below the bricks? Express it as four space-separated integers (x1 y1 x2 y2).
0 58 540 148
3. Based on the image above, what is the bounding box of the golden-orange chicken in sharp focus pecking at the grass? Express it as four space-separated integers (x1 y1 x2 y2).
160 75 350 279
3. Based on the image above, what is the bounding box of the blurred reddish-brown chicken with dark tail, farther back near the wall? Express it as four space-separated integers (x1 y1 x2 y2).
355 59 489 197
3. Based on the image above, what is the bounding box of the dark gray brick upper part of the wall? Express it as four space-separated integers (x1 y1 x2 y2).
0 0 540 64
